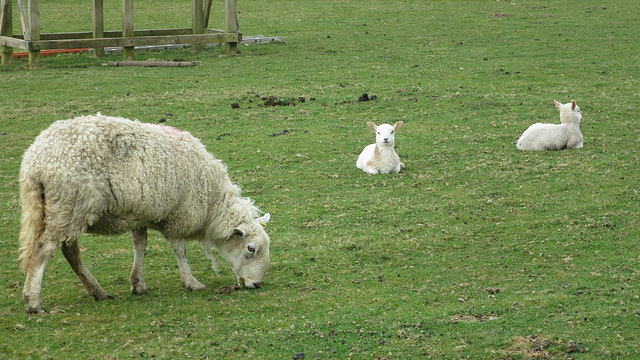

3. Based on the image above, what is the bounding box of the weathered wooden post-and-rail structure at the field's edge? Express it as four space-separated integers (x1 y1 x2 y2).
0 0 242 68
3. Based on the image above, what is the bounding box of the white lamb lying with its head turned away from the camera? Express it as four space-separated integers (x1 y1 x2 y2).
516 100 583 151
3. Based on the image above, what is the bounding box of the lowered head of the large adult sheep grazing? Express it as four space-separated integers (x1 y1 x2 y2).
218 213 271 288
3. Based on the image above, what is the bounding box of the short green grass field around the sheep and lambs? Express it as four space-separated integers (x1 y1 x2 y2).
0 0 640 359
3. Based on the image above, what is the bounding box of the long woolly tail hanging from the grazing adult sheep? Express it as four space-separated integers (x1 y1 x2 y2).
19 176 45 271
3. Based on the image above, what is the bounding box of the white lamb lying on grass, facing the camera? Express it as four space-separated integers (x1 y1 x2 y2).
356 121 404 174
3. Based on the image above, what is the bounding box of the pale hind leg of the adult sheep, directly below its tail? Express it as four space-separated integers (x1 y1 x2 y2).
22 231 58 313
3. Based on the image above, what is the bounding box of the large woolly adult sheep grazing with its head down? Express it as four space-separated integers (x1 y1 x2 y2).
20 113 270 313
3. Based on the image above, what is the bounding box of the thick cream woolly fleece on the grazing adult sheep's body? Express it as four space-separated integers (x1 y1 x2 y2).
20 113 259 268
